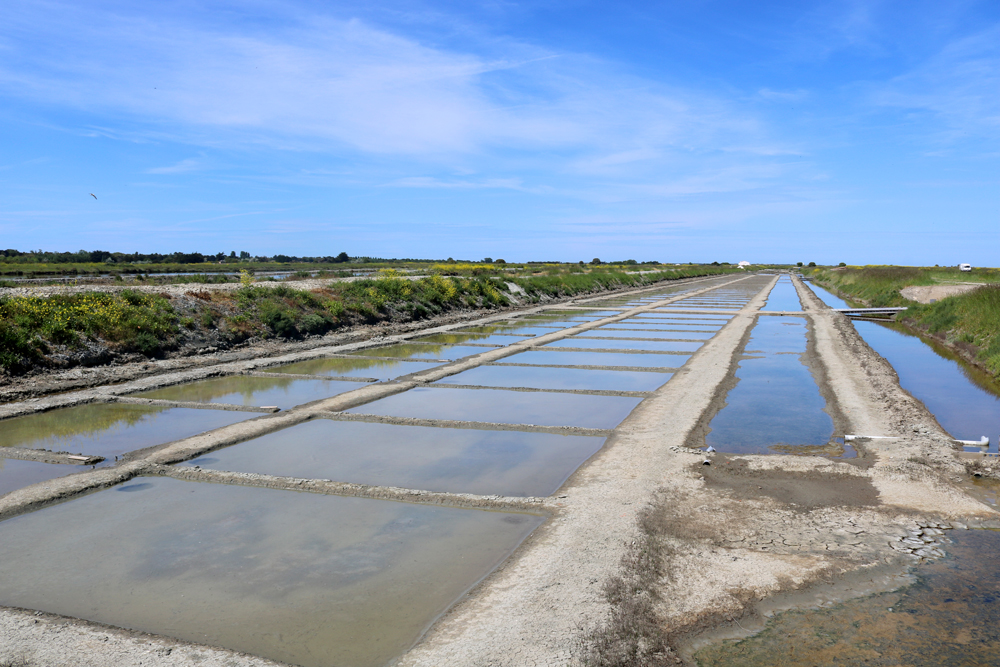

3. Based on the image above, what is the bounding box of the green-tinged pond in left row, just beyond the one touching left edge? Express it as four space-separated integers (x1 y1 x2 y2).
132 375 367 410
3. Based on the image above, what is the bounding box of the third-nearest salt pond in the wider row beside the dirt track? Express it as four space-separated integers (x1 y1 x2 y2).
347 386 642 429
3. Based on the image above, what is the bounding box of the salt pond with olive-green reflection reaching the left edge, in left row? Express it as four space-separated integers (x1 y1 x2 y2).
0 403 254 465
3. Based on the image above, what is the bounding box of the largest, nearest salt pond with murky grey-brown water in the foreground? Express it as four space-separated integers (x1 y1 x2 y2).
0 478 541 667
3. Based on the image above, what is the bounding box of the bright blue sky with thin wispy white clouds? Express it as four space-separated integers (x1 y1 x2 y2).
0 0 1000 266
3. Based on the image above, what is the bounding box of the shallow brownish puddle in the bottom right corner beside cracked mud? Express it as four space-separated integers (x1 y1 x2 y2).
695 530 1000 667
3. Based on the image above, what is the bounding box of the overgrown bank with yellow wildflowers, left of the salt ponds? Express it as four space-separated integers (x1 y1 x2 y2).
0 263 737 374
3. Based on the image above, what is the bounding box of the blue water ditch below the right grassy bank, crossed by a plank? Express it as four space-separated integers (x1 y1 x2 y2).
813 286 1000 452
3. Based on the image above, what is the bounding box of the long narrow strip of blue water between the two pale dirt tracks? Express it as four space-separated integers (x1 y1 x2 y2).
705 317 833 454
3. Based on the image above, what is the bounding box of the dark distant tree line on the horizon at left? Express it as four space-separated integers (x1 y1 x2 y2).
0 248 351 264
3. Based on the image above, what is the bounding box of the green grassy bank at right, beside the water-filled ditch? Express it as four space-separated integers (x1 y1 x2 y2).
812 266 1000 375
